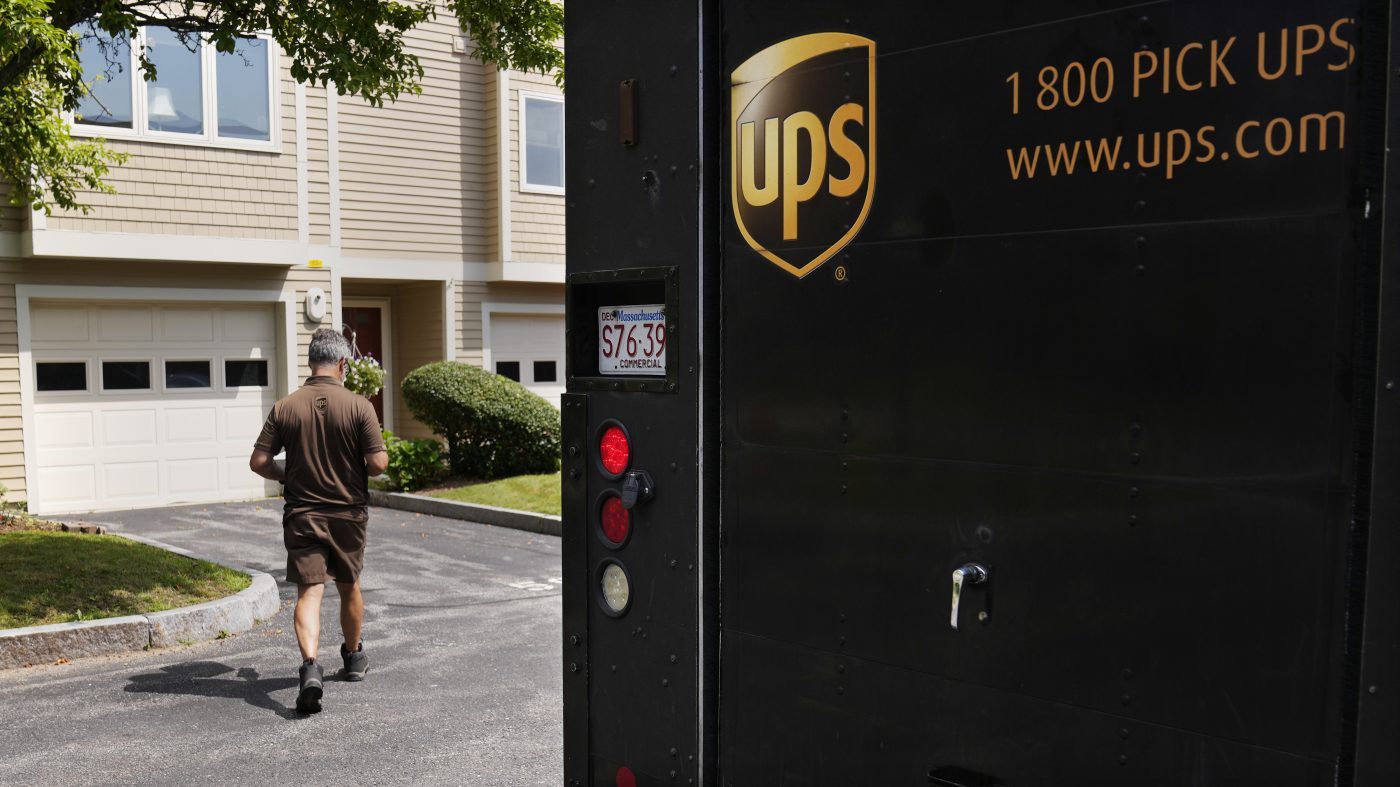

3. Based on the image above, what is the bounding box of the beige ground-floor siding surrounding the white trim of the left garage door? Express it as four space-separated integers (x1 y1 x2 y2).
0 259 330 500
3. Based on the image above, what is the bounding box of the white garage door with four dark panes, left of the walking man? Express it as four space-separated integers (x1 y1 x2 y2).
29 304 277 513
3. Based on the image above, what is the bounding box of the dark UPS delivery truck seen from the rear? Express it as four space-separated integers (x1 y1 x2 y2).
562 0 1400 787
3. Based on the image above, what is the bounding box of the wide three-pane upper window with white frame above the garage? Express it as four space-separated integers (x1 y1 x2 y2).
73 24 277 150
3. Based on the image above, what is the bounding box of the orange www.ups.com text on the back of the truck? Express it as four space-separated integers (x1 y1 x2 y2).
1007 111 1347 181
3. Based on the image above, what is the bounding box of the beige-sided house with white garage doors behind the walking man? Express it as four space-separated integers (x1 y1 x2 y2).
0 13 564 514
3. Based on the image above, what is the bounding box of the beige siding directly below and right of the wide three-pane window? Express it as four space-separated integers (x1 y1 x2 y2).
48 55 297 241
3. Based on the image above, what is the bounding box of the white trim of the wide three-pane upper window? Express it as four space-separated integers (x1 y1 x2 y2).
67 27 281 153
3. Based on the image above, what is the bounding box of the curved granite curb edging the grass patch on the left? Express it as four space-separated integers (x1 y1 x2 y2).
0 532 281 669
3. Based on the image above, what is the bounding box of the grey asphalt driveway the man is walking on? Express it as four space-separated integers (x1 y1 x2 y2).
0 500 563 787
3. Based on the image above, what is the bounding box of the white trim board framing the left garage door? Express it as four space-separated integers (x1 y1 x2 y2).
14 284 297 511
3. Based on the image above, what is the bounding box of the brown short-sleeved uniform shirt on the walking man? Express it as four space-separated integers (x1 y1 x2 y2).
256 377 384 518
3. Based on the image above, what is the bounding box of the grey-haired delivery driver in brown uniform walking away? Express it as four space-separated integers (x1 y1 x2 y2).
248 328 389 713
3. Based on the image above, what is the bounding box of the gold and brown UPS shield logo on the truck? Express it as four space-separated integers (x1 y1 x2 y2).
729 32 875 277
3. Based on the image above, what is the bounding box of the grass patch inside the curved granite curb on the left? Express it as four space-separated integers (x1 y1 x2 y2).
0 522 252 629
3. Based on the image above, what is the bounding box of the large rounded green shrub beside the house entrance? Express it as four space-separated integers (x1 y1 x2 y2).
403 361 560 479
